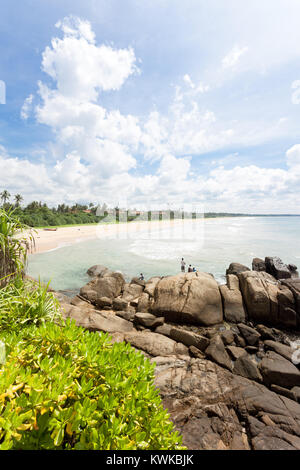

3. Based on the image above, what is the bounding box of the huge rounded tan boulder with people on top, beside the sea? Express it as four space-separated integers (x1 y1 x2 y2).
151 273 223 326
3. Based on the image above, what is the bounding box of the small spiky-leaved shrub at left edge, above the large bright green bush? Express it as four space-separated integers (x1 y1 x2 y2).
0 277 59 332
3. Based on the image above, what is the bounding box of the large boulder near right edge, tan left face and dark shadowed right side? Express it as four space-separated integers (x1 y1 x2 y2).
238 271 297 328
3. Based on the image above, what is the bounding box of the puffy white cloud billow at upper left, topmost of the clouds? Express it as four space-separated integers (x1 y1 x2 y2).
42 17 137 101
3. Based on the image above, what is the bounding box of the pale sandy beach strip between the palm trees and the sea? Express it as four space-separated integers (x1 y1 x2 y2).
22 219 200 254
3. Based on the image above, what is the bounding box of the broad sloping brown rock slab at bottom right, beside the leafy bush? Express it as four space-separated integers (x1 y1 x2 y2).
153 357 300 450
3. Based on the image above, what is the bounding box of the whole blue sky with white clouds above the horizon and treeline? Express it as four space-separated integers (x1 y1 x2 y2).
0 0 300 214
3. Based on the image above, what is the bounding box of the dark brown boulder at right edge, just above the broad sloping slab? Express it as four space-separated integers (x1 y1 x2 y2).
259 351 300 389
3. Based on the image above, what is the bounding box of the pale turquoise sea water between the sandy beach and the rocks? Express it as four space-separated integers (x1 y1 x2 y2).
28 216 300 290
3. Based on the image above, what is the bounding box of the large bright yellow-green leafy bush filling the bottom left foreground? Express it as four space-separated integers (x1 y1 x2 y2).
0 321 182 450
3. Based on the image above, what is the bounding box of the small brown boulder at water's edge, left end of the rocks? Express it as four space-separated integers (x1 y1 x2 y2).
80 272 125 303
